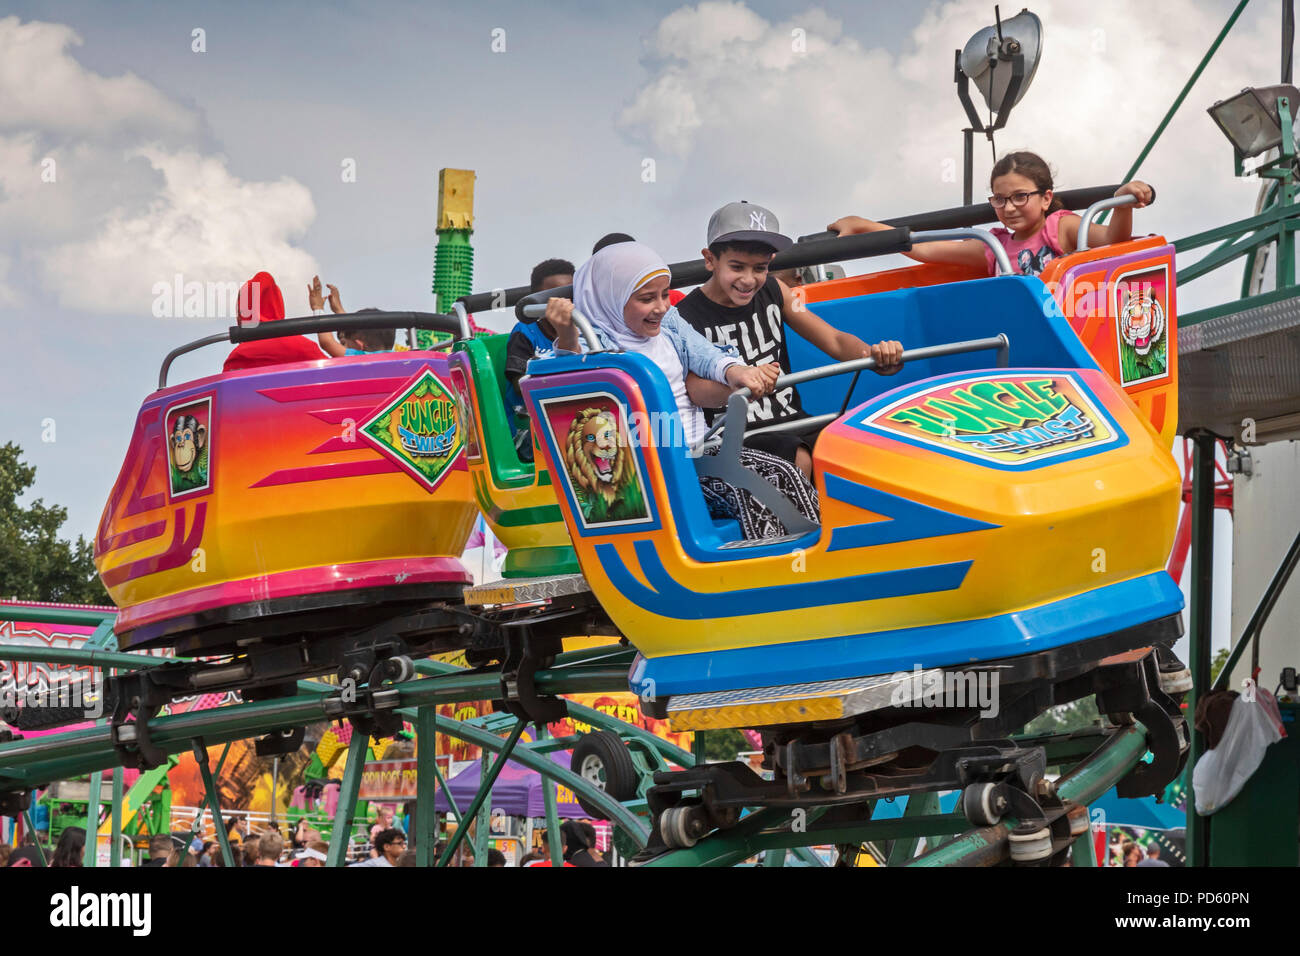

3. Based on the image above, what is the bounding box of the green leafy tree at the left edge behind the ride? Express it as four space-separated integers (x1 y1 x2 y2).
0 442 112 604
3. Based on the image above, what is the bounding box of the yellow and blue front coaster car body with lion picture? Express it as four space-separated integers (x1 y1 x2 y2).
524 277 1182 697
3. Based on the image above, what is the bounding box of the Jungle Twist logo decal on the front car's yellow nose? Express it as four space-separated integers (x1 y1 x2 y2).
861 372 1122 468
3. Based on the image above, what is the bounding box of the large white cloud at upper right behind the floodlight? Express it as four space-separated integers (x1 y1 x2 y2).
619 0 1277 308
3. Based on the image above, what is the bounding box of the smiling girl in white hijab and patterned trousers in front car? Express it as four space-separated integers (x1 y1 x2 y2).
546 242 820 538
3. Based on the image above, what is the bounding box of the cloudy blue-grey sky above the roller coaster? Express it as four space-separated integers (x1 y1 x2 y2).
0 0 1279 650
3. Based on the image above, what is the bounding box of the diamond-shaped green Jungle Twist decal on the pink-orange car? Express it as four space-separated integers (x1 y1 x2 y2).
360 368 465 492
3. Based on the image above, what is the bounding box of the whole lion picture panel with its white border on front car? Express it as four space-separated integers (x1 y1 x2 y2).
542 392 650 528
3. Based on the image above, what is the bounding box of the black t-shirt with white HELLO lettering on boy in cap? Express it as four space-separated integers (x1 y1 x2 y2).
677 276 803 427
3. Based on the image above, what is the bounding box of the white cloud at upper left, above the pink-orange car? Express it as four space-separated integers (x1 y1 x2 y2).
0 17 316 315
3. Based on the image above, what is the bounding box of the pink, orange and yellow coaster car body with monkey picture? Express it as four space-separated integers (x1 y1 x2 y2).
95 352 477 646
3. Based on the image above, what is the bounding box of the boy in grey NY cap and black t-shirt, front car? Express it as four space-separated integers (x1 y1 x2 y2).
677 200 902 477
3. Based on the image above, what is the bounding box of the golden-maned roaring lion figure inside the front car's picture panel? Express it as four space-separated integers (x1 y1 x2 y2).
563 407 646 524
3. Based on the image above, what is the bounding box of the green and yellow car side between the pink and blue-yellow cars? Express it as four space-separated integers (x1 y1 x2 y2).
451 336 579 578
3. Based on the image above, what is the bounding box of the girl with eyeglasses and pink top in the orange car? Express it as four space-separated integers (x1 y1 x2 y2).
827 152 1154 276
